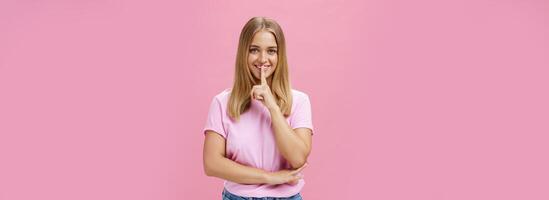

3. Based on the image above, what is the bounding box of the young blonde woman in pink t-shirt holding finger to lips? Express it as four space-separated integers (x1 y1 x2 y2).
203 17 313 200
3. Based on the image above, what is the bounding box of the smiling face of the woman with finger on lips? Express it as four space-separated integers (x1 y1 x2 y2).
248 31 278 79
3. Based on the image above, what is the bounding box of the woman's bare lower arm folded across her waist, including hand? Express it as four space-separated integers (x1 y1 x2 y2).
203 131 304 185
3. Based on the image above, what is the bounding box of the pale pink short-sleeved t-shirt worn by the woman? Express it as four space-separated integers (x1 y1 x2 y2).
204 89 313 197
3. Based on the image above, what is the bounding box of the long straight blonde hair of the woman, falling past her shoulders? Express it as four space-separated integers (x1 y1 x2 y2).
227 17 292 121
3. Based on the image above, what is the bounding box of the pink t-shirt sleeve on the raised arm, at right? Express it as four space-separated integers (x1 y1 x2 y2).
290 95 314 132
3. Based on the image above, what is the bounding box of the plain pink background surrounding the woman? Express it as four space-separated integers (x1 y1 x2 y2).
0 0 549 200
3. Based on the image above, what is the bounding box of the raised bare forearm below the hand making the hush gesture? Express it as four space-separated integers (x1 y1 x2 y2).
269 107 308 169
